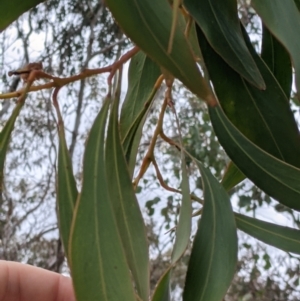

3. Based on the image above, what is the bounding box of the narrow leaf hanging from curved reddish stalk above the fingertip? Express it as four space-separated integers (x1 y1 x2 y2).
54 104 78 257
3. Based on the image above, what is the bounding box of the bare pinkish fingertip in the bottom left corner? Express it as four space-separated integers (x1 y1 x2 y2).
0 260 76 301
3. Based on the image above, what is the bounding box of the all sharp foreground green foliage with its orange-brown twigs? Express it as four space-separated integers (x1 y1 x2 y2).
0 0 300 301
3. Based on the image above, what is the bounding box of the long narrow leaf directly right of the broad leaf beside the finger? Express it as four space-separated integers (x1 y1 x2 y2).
105 96 150 301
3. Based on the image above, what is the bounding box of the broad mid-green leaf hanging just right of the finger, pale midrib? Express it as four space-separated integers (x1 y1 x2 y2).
69 99 136 301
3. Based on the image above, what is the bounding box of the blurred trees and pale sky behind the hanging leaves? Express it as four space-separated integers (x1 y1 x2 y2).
0 0 300 301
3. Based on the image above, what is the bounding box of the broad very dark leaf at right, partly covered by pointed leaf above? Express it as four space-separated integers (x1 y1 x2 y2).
197 27 300 168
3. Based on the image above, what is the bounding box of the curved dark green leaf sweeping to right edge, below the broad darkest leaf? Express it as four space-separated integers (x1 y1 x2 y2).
209 106 300 211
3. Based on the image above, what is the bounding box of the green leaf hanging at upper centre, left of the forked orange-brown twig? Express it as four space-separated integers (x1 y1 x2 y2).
120 52 161 177
